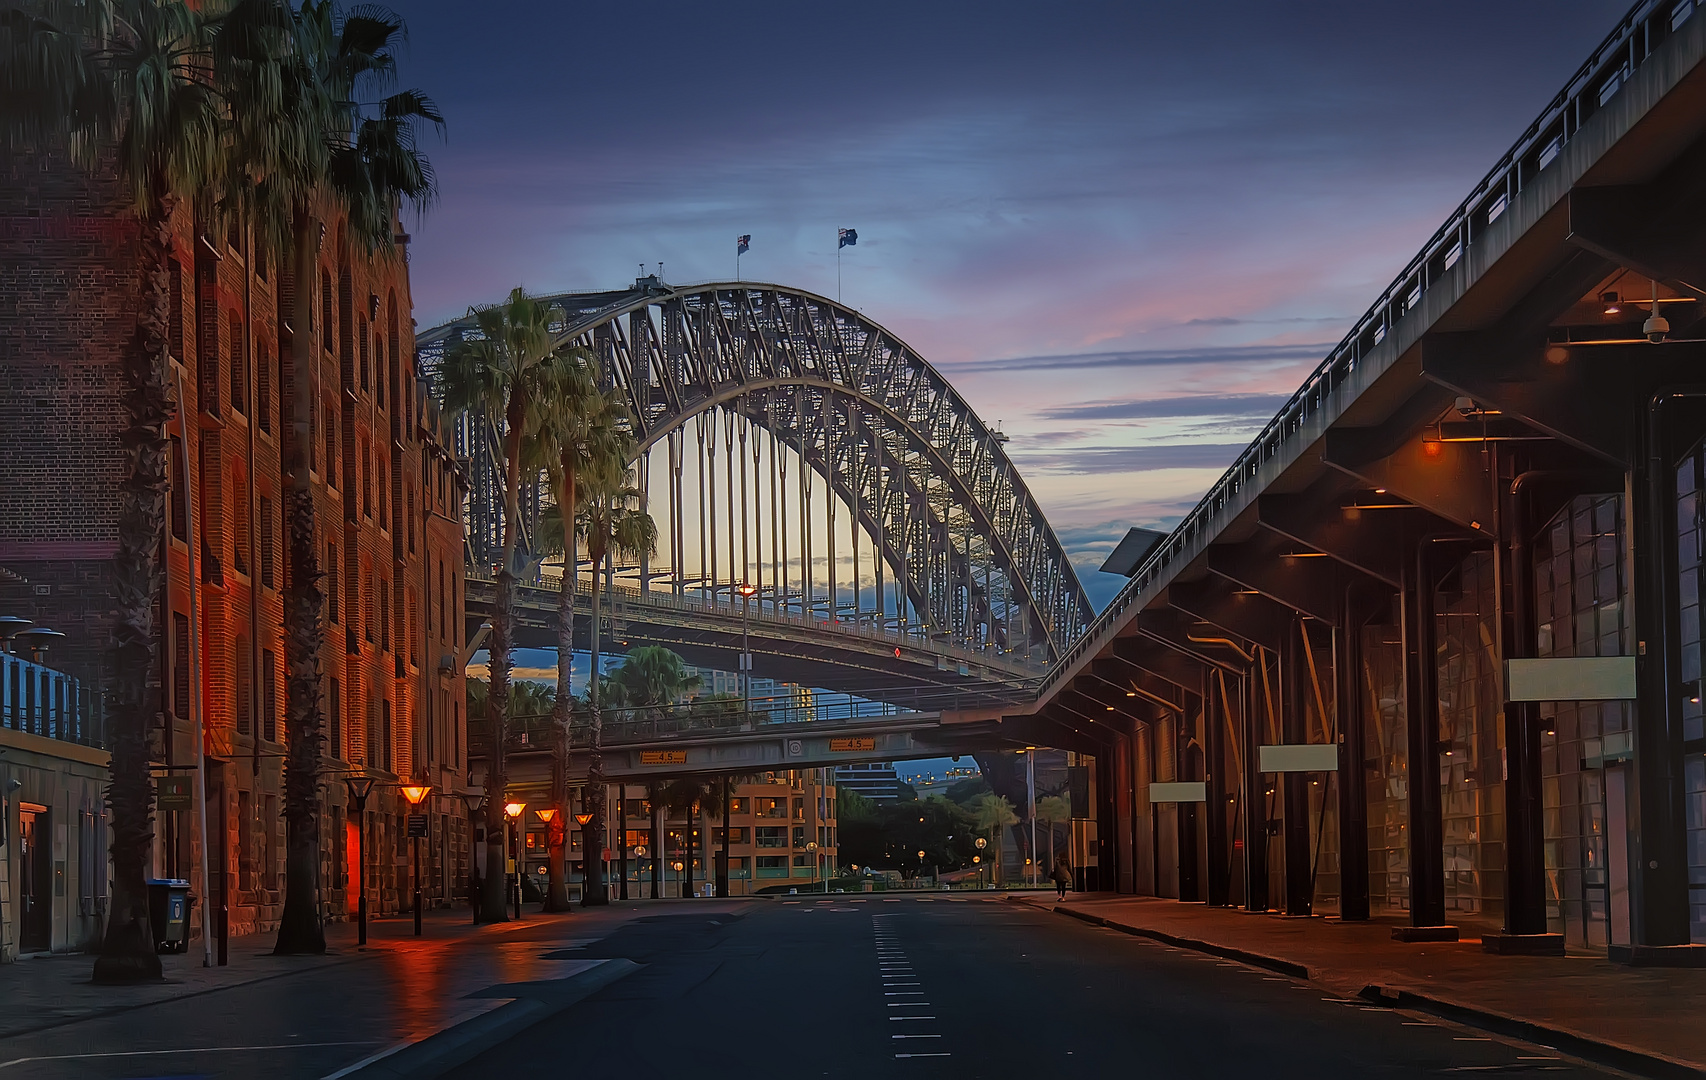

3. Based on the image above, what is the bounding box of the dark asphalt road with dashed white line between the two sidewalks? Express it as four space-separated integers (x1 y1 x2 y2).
450 896 1619 1080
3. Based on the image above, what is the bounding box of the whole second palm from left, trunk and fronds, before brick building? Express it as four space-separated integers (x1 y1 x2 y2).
215 0 444 955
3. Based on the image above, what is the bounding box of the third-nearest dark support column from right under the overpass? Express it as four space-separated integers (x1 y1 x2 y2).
1392 536 1457 942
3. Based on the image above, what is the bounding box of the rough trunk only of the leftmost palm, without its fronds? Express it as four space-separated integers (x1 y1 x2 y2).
94 200 174 984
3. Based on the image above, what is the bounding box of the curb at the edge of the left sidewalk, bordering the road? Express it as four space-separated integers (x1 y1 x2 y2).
321 959 640 1080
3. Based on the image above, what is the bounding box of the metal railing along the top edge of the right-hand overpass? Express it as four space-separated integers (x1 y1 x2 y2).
1037 0 1706 700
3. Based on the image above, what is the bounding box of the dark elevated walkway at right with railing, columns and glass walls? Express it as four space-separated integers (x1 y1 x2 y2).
1034 3 1706 964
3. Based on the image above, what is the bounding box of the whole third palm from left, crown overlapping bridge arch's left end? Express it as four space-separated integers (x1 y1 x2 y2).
442 288 560 923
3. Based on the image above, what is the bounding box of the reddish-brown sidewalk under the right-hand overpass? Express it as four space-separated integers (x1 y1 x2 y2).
1013 894 1706 1077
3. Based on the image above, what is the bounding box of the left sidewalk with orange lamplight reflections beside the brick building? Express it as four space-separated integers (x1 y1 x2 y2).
0 899 730 1080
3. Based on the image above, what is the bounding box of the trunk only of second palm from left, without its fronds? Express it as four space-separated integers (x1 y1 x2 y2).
273 210 331 955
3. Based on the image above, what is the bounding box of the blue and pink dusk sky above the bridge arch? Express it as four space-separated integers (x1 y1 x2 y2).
399 0 1624 602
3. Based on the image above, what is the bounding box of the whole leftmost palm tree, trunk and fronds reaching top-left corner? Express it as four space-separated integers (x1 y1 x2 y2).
0 0 225 983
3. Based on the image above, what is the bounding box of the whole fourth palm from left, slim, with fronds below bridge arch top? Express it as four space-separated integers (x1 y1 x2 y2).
527 361 628 911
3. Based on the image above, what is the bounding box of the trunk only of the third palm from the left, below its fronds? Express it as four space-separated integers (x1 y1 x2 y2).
479 389 527 923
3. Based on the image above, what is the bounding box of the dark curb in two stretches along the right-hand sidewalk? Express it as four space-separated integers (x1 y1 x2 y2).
1010 899 1706 1080
